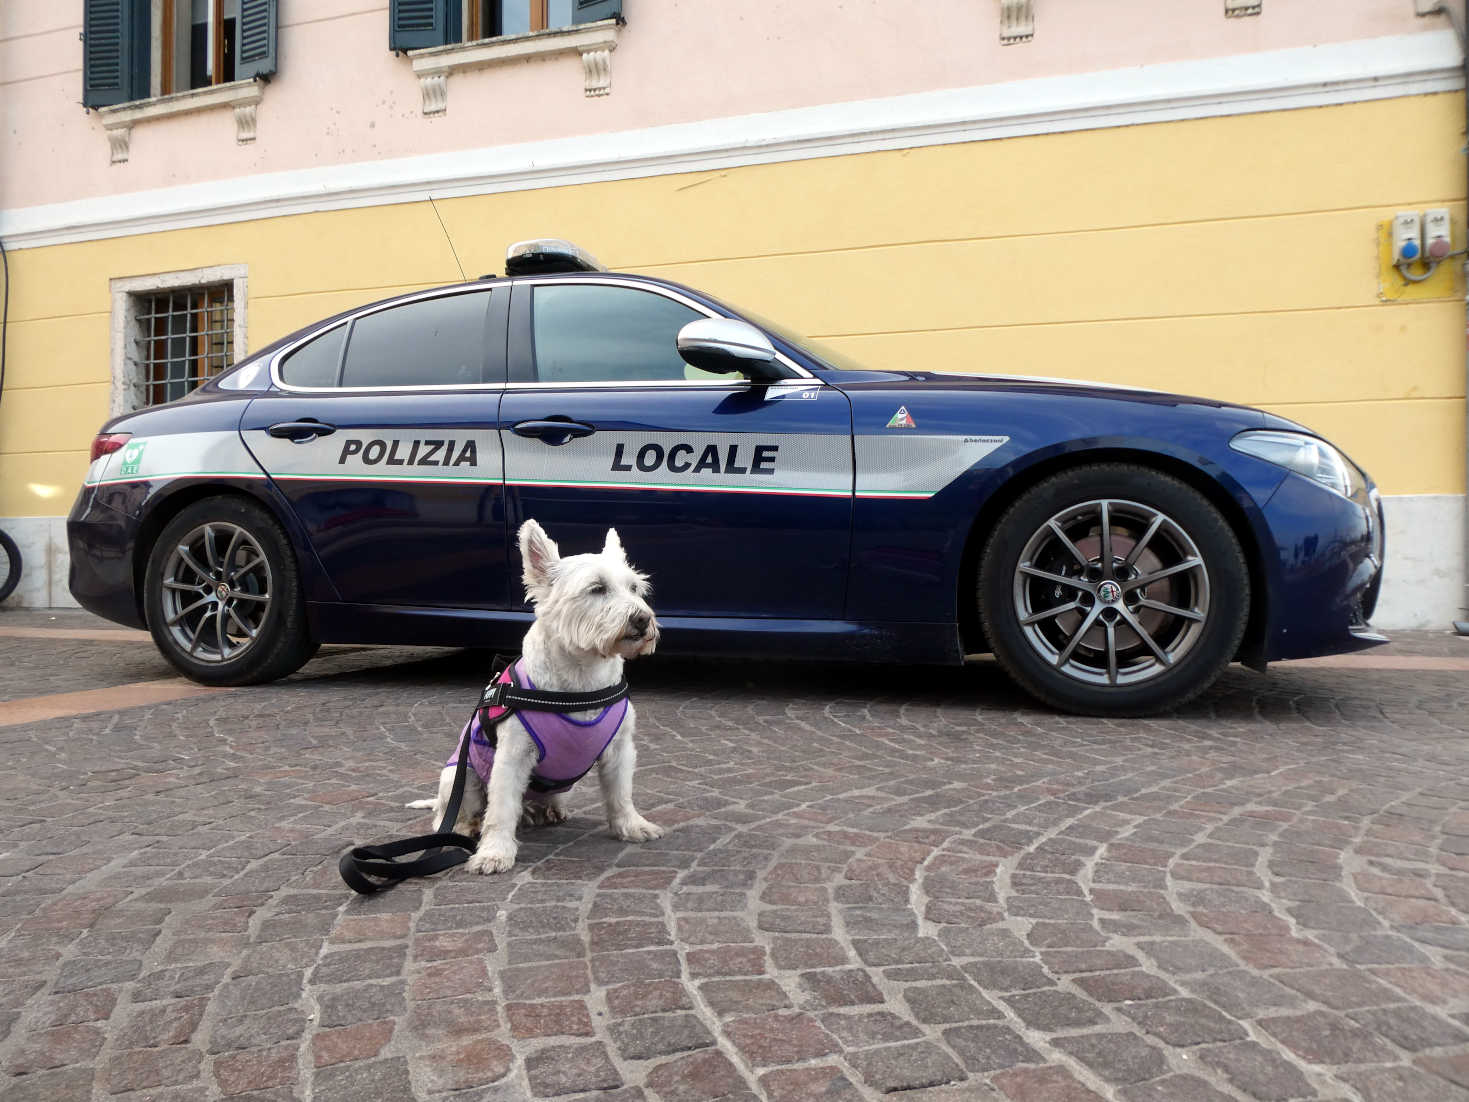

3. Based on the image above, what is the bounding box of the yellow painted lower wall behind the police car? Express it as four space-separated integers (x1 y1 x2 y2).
0 94 1466 516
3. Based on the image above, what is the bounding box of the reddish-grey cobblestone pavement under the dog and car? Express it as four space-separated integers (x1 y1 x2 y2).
0 617 1469 1102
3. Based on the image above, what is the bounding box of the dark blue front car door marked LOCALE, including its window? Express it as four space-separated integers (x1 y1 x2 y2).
499 278 852 620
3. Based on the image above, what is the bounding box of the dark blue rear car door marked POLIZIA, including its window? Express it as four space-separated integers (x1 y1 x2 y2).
241 287 510 608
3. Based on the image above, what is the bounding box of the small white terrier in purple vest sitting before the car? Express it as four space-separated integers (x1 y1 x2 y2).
408 520 663 873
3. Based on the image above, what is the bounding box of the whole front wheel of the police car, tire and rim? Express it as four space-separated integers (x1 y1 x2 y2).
978 463 1250 716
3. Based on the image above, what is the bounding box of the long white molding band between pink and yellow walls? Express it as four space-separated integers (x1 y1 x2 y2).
0 29 1463 248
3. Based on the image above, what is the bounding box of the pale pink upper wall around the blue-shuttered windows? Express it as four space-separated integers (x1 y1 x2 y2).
0 0 1445 207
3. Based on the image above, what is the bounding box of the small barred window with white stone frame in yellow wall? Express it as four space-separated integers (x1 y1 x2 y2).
112 264 245 413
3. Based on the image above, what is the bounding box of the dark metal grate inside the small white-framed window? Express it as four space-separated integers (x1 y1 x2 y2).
132 284 235 406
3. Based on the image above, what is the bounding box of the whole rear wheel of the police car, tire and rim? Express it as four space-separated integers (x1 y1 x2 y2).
144 497 317 685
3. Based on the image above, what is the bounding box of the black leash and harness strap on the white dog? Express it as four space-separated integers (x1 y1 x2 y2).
336 655 627 895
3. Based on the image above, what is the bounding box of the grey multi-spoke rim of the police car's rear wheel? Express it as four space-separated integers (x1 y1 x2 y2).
163 520 272 663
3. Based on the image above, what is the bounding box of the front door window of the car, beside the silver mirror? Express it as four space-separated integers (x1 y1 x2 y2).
530 284 710 382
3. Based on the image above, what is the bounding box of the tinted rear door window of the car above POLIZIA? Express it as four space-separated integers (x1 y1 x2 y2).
337 291 491 386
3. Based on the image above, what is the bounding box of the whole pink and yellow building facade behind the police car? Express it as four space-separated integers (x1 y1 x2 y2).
0 0 1469 627
